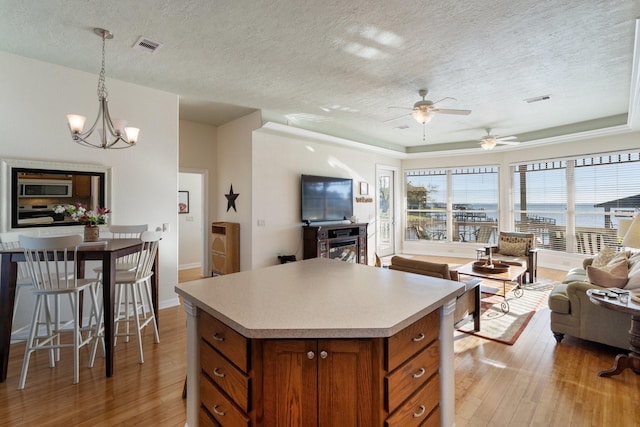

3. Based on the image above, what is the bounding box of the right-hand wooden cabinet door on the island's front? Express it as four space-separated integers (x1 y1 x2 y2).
318 339 382 427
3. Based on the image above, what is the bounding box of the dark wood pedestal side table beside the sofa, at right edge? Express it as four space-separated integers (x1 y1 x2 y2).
587 289 640 377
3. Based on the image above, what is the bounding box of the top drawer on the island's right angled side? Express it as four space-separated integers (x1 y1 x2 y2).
386 310 440 372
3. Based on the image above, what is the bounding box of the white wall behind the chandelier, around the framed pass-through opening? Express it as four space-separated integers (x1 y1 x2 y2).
0 52 178 332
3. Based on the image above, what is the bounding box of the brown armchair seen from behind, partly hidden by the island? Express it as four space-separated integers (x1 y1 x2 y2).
389 255 480 331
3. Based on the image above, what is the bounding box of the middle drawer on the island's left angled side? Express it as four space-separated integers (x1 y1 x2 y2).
200 340 249 412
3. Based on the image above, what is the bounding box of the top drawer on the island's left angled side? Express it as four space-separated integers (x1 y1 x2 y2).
200 311 249 372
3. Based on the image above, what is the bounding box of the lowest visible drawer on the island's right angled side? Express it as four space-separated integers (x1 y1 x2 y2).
385 374 440 427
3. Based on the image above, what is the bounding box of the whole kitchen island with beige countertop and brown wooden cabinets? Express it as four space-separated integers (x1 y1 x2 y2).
176 258 464 427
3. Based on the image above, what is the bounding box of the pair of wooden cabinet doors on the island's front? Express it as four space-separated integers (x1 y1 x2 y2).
262 339 383 427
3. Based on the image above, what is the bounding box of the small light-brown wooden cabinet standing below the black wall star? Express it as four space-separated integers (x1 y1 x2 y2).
210 222 240 276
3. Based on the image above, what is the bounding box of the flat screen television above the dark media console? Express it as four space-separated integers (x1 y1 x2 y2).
301 175 353 224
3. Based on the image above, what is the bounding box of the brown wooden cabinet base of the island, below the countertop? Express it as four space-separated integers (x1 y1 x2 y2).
199 310 440 427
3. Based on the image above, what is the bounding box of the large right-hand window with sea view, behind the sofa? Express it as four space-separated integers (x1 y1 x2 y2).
512 153 640 254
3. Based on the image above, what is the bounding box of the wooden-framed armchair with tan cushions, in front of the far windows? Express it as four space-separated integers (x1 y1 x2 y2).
485 231 538 283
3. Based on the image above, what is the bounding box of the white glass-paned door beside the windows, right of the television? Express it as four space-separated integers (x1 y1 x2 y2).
376 166 397 257
